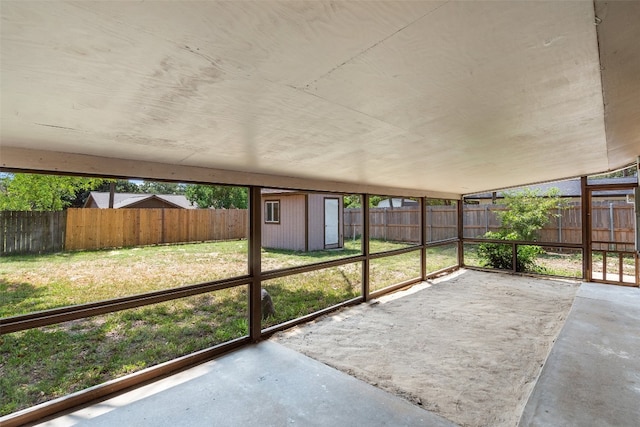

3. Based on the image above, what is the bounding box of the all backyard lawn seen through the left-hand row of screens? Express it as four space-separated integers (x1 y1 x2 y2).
0 239 455 416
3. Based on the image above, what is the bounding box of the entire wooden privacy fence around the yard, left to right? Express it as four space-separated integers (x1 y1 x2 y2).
0 203 635 255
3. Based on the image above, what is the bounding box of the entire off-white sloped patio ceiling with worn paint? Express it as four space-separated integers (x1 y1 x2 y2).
0 0 640 194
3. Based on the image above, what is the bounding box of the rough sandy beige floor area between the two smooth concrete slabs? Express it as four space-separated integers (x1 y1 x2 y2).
274 271 579 426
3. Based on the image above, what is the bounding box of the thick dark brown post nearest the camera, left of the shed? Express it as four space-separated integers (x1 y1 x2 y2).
249 187 262 342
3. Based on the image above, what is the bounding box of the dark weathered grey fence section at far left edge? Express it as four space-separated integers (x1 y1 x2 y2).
0 211 67 255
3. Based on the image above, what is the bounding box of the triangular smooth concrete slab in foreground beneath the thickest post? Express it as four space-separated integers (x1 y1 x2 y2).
35 341 455 427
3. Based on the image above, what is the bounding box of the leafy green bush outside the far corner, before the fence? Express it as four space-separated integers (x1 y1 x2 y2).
478 188 566 271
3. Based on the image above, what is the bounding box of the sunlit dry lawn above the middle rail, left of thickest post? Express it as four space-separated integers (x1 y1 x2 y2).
0 241 247 317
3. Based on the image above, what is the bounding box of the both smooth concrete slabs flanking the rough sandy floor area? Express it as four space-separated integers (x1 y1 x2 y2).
32 283 640 427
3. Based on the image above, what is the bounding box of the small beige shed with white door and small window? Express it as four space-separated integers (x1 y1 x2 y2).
262 189 344 252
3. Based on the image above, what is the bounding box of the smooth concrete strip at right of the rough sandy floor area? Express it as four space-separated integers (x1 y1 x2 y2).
520 283 640 427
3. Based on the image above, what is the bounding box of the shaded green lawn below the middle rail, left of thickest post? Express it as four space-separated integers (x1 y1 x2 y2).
0 287 248 415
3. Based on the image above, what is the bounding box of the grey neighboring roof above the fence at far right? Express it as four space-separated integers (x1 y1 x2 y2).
464 176 638 200
